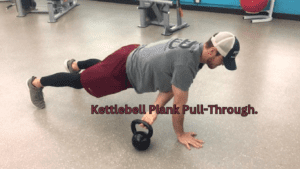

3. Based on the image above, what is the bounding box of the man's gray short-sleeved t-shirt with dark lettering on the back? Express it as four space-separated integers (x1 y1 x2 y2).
126 38 203 93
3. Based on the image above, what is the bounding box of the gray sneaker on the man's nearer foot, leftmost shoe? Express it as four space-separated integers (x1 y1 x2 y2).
27 76 45 109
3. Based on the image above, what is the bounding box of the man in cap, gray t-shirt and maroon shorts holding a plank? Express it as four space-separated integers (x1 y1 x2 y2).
27 32 240 149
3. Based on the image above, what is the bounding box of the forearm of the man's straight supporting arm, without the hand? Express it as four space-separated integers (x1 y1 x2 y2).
172 104 184 137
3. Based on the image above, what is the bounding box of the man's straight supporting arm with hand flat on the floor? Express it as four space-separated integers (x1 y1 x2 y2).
172 85 204 150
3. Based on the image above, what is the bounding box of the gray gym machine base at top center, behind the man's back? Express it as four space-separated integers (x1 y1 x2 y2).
138 0 189 36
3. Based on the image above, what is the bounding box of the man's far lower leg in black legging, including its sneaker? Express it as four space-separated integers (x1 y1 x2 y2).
64 59 101 74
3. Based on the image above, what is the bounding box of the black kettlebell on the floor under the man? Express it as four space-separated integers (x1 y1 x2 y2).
131 119 153 150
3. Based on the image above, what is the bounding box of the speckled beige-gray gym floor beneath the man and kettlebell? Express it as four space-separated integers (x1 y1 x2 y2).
0 1 300 169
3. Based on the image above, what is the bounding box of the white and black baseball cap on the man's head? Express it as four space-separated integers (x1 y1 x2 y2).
211 32 240 70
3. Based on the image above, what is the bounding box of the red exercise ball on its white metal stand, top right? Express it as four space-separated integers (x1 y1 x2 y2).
240 0 275 23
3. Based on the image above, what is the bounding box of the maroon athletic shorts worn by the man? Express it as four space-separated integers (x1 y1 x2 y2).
78 44 139 98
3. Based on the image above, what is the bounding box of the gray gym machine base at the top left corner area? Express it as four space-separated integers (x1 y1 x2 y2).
16 0 79 23
